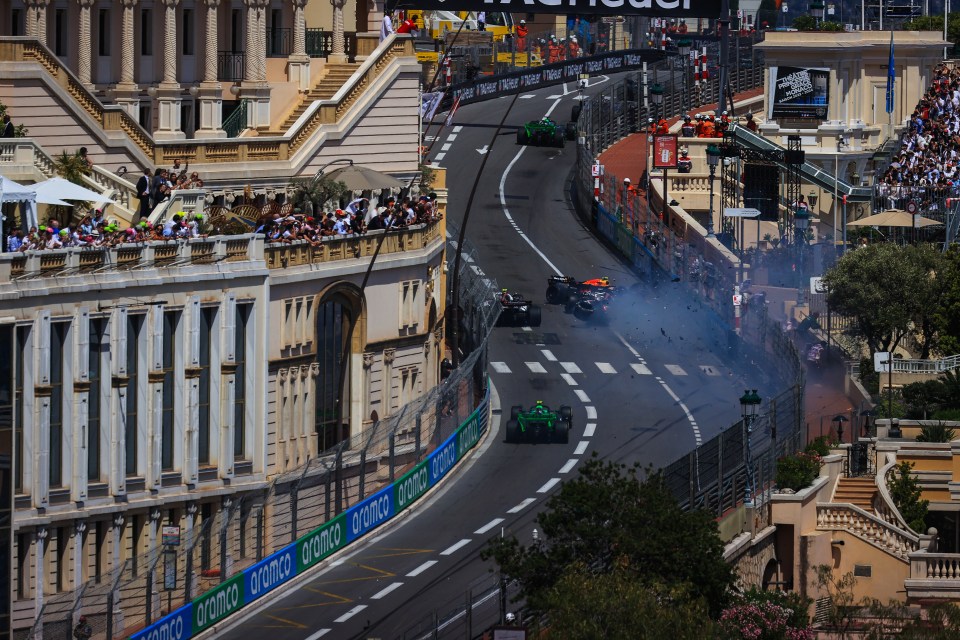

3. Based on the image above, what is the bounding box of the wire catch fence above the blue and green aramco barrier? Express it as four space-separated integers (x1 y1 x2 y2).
22 234 500 640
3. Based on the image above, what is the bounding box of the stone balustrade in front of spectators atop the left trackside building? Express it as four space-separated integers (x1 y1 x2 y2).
0 221 445 283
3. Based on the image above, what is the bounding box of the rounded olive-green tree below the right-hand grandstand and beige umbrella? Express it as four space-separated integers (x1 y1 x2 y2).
824 243 928 352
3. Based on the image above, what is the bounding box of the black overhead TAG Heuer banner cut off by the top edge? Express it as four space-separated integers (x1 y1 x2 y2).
387 0 720 18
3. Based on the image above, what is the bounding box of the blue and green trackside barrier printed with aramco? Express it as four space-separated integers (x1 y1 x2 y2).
130 387 490 640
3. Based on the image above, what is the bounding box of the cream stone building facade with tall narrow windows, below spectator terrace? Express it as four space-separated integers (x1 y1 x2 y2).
0 215 444 637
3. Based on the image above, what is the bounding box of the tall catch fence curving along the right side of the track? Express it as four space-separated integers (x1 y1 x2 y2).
572 52 806 516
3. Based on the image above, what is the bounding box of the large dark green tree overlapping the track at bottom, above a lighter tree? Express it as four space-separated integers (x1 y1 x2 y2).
484 458 734 616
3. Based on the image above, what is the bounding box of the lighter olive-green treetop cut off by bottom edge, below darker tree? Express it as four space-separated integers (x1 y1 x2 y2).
533 564 714 640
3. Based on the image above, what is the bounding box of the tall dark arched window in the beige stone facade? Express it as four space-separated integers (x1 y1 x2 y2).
314 293 355 451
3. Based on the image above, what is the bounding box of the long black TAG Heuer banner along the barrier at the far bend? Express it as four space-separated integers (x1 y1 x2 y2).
445 49 664 105
